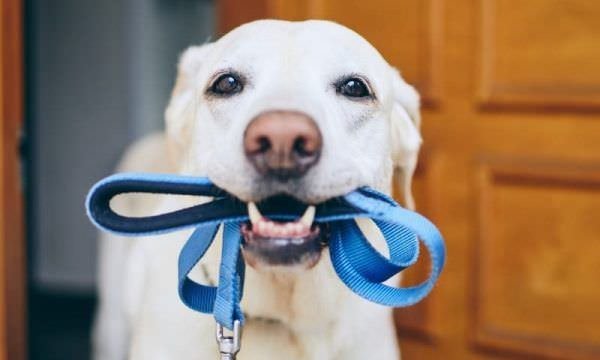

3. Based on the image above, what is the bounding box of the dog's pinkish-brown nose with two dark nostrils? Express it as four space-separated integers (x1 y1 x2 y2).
244 111 322 181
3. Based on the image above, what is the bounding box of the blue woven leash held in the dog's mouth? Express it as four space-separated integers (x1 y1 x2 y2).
86 173 446 330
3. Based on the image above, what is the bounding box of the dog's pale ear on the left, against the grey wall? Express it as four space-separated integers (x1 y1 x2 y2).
165 43 212 167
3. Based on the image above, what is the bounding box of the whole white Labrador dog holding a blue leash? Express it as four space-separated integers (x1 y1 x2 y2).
93 20 421 360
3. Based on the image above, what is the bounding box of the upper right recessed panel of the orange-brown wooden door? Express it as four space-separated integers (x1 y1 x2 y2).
479 0 600 108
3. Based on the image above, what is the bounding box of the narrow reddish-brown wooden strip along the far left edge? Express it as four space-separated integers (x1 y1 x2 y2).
0 0 25 360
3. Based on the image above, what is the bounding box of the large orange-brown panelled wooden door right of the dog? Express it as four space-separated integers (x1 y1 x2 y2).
219 0 600 359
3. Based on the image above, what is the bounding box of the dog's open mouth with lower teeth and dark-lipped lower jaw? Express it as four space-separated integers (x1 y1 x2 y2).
241 196 327 269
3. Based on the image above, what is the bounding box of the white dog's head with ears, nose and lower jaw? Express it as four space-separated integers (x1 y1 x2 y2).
167 20 420 266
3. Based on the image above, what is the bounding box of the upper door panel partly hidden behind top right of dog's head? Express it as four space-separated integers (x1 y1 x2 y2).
308 0 442 105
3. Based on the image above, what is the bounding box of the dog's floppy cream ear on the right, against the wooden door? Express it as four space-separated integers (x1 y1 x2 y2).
390 68 422 209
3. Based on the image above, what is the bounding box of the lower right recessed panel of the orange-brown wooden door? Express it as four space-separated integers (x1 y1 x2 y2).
472 163 600 359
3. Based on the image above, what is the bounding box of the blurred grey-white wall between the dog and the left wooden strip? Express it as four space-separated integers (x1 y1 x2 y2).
26 0 214 291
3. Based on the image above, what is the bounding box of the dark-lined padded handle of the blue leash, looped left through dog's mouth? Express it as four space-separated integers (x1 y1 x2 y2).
86 173 360 236
